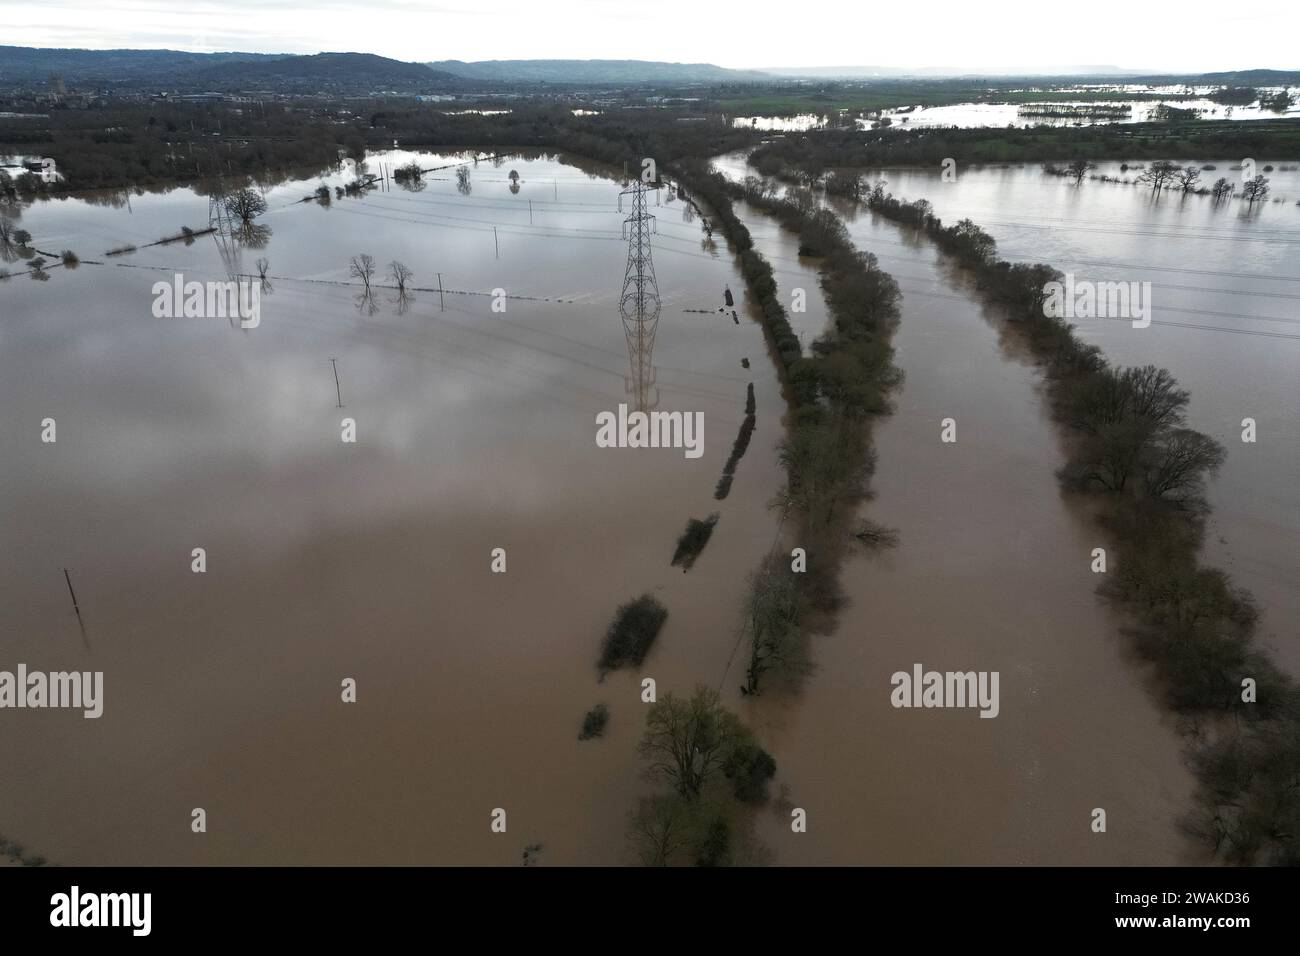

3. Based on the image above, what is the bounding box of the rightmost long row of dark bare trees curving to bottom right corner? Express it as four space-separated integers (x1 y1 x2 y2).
852 183 1300 865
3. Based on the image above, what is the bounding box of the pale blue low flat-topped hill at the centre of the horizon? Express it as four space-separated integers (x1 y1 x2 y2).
428 60 772 85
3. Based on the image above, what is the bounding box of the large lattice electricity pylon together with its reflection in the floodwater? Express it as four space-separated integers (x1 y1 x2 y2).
619 182 659 411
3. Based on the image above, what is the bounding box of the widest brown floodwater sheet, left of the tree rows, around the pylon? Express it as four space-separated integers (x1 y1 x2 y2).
0 153 784 865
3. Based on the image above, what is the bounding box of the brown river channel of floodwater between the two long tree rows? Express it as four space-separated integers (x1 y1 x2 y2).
715 155 1200 865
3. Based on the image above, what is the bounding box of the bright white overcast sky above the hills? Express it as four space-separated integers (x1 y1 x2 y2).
10 0 1300 72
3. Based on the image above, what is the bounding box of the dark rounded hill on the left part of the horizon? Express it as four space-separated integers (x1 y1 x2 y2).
185 53 464 94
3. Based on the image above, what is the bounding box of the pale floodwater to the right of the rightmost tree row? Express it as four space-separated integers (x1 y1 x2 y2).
847 156 1300 675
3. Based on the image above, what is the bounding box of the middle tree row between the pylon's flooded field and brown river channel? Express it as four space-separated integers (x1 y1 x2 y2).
686 163 902 693
